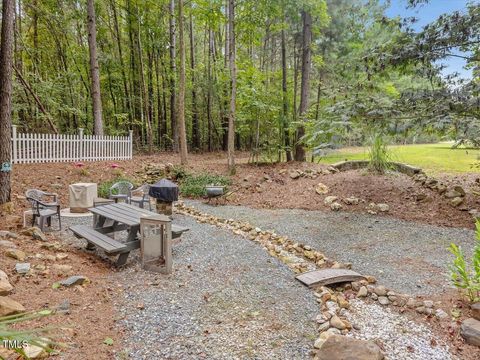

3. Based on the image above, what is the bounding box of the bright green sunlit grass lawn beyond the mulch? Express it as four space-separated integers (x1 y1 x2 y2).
320 143 480 173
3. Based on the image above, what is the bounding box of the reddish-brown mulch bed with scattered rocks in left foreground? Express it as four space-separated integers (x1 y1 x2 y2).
0 224 122 359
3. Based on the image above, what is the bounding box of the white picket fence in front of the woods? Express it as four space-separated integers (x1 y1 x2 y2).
12 126 133 164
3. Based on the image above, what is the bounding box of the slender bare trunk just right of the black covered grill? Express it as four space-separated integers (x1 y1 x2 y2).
178 0 188 165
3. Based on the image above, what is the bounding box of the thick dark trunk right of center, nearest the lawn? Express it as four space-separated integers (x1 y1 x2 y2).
295 11 312 161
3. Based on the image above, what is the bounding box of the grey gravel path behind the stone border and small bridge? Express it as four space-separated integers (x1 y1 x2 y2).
186 201 475 295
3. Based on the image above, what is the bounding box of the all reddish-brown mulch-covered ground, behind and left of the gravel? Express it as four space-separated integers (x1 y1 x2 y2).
0 153 480 359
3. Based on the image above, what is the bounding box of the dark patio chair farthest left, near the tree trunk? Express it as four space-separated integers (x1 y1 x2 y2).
25 189 62 231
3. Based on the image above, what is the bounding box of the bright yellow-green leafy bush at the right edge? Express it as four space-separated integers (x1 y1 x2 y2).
448 220 480 302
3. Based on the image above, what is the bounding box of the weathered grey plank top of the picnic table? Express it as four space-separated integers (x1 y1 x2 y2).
89 203 188 234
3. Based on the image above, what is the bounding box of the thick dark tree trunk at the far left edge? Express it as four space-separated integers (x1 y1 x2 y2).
0 0 15 205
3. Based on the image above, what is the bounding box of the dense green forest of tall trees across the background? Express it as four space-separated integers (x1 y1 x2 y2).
0 0 480 167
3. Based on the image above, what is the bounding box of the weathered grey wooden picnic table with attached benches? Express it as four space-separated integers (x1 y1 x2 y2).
70 203 189 266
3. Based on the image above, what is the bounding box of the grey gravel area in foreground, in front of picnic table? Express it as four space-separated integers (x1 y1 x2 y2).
114 215 319 359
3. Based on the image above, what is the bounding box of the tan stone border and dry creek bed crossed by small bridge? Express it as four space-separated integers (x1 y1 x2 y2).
176 203 449 359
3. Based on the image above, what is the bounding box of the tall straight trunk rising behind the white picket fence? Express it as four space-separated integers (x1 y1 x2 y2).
87 0 103 135
